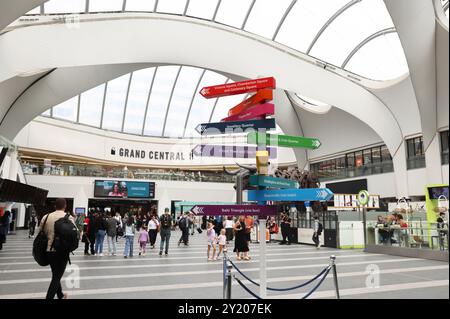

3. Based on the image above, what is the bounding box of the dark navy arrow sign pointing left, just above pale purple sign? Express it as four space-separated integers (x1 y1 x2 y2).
195 119 276 135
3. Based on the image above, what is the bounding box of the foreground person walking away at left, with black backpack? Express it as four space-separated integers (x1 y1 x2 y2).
40 198 79 299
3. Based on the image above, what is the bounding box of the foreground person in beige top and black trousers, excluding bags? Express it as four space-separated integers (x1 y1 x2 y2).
41 198 76 299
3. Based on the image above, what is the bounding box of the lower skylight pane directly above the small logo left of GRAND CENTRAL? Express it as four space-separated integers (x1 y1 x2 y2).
102 74 130 131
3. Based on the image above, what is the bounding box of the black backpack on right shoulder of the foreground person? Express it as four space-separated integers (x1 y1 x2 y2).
52 214 80 255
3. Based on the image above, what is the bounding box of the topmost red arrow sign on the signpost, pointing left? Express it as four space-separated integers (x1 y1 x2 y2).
200 77 276 99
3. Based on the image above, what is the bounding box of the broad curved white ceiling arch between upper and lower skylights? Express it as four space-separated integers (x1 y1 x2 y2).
0 14 402 155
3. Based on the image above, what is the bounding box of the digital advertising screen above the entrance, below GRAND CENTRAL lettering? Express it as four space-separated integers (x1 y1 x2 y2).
94 180 155 198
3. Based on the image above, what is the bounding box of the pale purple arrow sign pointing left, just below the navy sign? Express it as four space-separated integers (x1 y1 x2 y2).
192 144 277 159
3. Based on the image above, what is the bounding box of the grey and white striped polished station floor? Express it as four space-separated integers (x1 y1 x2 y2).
0 231 449 299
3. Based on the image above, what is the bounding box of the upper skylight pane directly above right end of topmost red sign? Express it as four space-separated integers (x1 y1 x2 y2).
244 0 292 39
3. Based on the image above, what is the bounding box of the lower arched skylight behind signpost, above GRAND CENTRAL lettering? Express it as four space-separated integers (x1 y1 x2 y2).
42 66 280 138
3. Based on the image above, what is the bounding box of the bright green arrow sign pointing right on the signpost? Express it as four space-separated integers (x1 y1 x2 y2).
247 132 321 150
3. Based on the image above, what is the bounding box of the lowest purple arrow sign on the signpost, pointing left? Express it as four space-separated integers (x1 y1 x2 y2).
191 205 277 217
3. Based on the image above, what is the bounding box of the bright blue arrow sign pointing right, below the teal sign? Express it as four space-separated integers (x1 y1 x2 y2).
248 188 333 202
